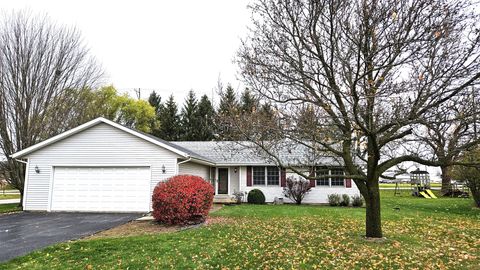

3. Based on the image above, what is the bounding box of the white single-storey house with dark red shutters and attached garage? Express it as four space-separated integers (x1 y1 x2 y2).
12 118 359 212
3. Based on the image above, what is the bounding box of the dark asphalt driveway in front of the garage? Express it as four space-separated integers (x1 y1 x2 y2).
0 212 141 262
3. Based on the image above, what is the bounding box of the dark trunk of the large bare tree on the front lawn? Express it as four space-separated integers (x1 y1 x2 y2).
364 179 383 238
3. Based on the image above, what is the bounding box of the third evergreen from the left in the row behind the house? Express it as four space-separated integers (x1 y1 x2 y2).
180 90 201 141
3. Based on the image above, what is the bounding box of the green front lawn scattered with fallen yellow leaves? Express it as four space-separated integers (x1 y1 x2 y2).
0 191 480 269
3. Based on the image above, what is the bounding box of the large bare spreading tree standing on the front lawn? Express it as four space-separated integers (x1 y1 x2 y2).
232 0 480 238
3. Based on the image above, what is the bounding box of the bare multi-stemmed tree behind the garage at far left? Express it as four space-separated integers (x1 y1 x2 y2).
0 11 102 205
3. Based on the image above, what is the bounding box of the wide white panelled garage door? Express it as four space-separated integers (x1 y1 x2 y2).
51 167 151 212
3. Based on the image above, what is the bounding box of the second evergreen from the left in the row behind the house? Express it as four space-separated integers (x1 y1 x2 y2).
158 95 180 141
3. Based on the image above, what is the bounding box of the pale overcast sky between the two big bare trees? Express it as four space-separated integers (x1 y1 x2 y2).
1 0 250 102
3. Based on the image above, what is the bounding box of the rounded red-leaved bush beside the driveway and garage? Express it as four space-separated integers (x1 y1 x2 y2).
152 175 214 224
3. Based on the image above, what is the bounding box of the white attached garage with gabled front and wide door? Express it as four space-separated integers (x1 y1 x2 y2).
11 118 212 212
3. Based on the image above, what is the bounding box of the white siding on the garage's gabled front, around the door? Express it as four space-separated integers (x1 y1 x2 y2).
25 123 179 211
